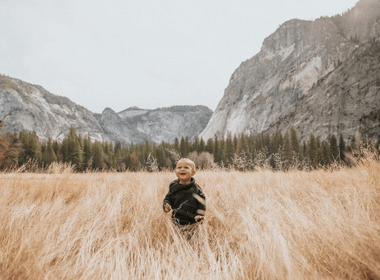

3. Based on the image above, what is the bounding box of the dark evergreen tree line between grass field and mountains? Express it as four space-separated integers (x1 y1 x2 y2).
0 127 379 172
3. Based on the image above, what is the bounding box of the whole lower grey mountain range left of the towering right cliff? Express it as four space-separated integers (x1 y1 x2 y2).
0 76 212 145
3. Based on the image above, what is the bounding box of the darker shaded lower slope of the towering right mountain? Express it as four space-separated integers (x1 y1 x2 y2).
265 42 380 140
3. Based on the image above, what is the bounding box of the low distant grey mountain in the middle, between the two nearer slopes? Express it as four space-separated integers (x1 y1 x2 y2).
96 106 212 144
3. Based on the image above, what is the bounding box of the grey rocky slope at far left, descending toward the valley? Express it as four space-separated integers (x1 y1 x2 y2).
0 76 108 141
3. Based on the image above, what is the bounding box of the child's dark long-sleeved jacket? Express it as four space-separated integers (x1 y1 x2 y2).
164 178 206 225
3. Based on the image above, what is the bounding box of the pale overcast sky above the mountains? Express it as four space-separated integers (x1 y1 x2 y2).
0 0 358 113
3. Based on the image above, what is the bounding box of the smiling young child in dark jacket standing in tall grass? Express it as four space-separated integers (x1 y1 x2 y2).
163 158 206 226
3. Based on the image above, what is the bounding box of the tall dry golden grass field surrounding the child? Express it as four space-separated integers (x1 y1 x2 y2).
0 161 380 279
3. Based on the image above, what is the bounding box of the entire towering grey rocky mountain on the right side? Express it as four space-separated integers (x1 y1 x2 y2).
200 0 380 140
